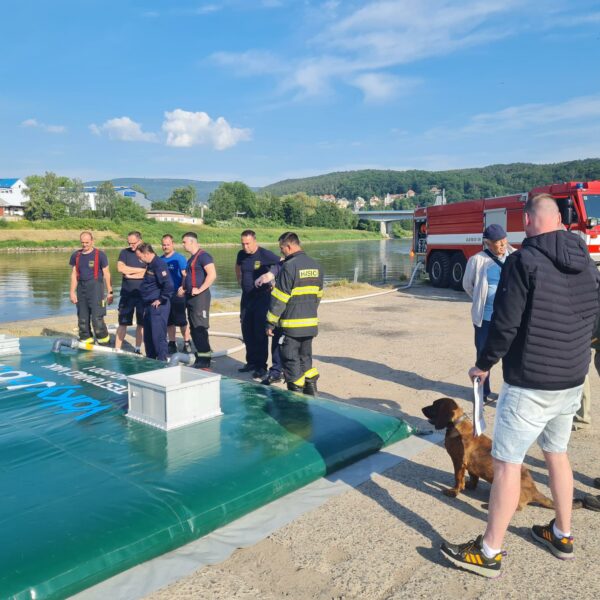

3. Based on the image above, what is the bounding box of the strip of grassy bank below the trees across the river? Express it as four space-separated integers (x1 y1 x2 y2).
0 219 381 250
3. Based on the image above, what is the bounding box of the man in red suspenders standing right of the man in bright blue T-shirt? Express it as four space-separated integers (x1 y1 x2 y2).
177 231 217 369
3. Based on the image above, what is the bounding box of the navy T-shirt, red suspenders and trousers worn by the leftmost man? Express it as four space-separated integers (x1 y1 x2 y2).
69 248 112 344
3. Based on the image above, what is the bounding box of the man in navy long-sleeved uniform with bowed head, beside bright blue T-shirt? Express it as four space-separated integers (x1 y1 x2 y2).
135 243 173 361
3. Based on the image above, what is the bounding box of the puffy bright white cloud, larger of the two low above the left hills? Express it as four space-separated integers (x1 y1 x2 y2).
162 108 252 150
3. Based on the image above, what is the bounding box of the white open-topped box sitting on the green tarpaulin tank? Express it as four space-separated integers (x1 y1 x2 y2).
127 365 223 431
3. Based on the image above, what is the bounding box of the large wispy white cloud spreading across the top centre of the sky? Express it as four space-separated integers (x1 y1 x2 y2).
212 0 530 102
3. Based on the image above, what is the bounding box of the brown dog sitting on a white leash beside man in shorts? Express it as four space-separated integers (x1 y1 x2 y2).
422 398 554 510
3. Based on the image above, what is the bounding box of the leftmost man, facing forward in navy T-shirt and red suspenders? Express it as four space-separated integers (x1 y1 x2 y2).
69 231 113 345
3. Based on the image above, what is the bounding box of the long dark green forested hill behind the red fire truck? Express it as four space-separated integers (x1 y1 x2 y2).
263 158 600 202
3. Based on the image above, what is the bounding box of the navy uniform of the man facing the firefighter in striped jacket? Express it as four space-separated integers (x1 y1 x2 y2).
236 246 280 371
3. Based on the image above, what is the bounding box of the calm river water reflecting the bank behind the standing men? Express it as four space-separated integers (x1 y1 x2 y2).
0 240 412 322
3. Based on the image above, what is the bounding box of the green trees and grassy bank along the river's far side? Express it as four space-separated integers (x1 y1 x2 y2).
0 173 380 249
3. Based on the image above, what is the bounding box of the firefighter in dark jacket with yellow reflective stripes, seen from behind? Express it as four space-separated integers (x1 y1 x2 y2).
266 231 323 396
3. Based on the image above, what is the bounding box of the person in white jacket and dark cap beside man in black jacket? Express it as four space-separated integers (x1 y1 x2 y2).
463 224 515 402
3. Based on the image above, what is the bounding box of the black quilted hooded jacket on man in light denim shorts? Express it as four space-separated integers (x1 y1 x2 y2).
476 230 600 390
